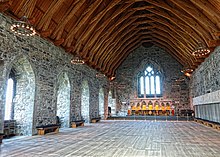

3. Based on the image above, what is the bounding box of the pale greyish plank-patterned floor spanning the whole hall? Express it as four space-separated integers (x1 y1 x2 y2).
0 120 220 157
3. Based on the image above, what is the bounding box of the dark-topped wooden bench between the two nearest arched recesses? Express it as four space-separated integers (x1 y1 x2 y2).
36 124 60 135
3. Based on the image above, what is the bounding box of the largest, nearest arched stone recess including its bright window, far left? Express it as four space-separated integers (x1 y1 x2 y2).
4 58 35 135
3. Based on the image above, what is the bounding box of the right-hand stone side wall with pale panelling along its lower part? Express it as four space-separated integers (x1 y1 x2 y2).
190 47 220 122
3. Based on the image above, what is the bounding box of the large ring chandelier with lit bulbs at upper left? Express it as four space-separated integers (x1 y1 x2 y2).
11 16 36 36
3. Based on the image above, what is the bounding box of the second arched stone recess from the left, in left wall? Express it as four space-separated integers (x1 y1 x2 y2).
57 73 70 127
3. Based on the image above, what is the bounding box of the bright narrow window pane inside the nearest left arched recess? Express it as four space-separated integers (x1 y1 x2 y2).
4 78 14 120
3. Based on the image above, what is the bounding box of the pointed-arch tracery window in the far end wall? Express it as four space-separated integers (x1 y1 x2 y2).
137 65 162 98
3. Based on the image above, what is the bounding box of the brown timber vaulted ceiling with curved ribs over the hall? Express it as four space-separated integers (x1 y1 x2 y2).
0 0 220 77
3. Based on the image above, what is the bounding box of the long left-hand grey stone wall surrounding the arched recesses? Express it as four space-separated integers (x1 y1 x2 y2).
0 14 108 135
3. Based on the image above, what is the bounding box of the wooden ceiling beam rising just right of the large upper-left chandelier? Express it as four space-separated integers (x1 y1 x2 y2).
37 0 65 31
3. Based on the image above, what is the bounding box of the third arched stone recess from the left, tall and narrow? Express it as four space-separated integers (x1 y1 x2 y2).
81 80 90 123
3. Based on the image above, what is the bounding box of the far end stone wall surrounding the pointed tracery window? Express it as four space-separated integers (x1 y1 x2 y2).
115 45 190 112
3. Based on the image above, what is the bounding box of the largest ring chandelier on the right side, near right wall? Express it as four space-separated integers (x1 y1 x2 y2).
192 42 211 58
